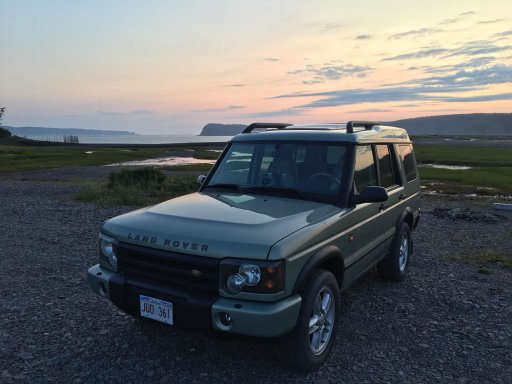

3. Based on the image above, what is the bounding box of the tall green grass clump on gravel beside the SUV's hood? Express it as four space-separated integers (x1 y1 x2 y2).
75 167 199 207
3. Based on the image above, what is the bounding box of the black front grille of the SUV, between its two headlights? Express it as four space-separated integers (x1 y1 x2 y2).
117 243 219 294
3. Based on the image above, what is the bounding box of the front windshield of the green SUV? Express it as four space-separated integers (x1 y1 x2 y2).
206 142 346 198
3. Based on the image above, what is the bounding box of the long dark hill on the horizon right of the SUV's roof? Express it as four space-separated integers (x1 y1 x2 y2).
387 113 512 136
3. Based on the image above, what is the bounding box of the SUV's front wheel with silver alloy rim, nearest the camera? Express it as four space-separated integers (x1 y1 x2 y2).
274 269 340 371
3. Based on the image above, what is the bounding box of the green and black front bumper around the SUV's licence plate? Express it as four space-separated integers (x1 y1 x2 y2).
87 264 302 337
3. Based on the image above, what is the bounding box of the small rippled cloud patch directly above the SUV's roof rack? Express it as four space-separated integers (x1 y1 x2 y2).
288 63 372 84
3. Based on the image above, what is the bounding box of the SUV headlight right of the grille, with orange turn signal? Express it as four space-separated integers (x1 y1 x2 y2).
220 259 284 295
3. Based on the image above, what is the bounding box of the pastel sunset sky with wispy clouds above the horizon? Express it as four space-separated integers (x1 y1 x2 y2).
0 0 512 134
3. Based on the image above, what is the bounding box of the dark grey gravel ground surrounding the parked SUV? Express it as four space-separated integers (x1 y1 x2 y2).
0 180 512 384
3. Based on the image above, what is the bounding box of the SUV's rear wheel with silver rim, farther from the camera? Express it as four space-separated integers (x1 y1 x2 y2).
377 223 412 281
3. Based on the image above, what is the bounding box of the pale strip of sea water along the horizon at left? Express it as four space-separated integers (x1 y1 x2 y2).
21 135 233 144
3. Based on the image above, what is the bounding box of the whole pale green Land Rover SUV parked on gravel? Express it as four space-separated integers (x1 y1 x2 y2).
88 121 420 370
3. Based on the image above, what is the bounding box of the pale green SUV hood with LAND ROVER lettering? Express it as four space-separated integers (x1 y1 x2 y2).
103 192 341 259
